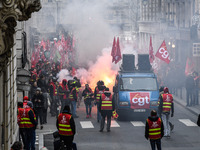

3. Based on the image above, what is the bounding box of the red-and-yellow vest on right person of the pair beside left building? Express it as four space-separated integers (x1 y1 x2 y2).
21 108 36 128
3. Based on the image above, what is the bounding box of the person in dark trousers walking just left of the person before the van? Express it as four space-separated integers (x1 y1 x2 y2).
82 84 94 118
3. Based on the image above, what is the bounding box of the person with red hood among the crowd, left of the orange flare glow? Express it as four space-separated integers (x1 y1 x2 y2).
58 79 70 111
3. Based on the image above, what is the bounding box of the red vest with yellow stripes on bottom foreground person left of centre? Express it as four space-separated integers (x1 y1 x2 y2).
58 113 74 136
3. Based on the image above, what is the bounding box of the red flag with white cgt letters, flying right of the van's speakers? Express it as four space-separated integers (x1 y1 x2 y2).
155 40 170 64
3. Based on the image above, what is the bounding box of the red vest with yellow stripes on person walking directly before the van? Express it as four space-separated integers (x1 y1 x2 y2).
101 94 112 110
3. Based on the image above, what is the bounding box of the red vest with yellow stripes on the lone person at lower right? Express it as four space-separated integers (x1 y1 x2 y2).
147 118 161 139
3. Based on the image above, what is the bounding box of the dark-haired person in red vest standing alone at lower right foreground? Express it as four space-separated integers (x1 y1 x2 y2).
145 110 164 150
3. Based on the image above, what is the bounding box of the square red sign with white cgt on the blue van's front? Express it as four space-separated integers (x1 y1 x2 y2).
130 92 150 109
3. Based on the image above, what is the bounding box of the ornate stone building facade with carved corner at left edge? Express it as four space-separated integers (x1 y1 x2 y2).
0 0 41 150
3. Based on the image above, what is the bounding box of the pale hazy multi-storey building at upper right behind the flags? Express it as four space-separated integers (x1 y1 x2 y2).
139 0 198 68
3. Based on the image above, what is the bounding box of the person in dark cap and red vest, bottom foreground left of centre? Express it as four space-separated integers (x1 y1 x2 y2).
56 105 76 150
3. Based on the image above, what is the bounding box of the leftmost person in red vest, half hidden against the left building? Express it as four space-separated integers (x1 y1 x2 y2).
17 102 26 149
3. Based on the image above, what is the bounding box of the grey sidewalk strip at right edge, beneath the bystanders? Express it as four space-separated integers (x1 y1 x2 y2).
173 89 200 115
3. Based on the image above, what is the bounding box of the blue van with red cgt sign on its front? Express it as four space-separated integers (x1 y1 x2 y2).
113 54 159 118
